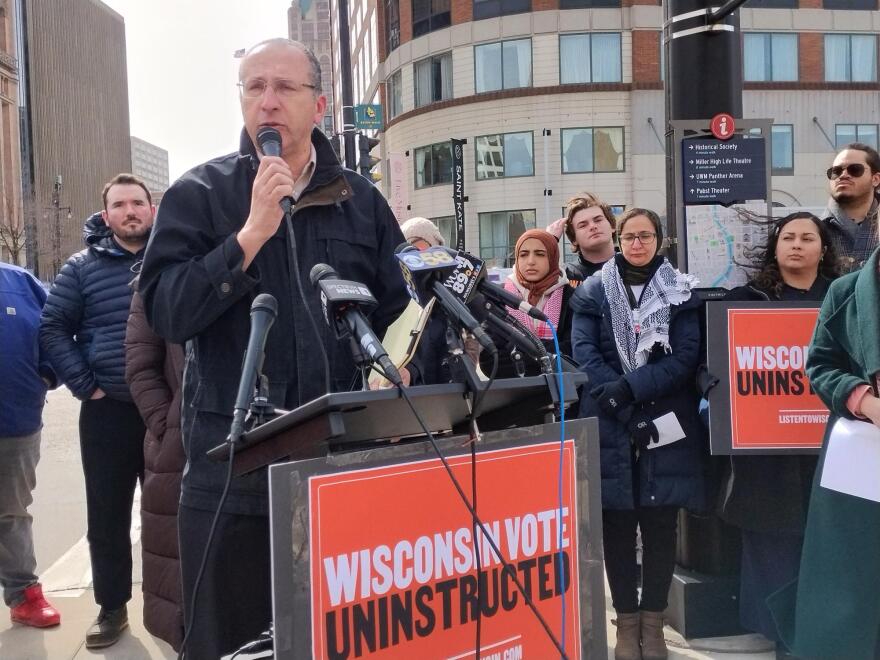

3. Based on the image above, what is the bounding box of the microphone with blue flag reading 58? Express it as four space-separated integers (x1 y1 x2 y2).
395 243 498 355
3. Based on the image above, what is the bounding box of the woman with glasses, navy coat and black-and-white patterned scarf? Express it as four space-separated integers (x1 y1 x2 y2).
572 208 704 660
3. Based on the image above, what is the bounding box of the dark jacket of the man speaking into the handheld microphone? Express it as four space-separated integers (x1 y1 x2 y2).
140 130 408 515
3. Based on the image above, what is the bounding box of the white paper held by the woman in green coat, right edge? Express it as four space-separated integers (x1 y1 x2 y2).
821 419 880 502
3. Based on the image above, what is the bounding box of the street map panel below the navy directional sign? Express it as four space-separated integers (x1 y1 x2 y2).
685 203 767 289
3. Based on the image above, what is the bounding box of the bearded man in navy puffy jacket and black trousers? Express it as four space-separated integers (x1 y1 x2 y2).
40 174 156 649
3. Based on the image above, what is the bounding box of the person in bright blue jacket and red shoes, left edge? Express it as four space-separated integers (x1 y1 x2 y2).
0 262 61 628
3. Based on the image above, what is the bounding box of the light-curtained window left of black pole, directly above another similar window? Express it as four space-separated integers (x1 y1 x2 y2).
559 32 623 85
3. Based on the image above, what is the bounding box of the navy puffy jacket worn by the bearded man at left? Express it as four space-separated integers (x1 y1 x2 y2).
40 213 143 401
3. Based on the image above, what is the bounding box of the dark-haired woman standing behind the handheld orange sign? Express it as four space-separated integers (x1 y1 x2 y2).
720 213 839 657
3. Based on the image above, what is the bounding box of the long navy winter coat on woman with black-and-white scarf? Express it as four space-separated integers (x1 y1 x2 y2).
571 277 705 510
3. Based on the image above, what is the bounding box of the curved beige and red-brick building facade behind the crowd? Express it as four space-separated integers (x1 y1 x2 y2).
332 0 880 265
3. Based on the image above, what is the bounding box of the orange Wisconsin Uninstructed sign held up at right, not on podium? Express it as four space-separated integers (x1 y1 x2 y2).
707 302 829 454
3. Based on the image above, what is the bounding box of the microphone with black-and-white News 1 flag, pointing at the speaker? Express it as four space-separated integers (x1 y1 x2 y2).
309 264 403 385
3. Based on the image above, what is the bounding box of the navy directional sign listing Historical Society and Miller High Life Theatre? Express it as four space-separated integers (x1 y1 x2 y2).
681 135 767 206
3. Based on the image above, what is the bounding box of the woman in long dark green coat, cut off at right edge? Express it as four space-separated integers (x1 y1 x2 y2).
768 251 880 660
